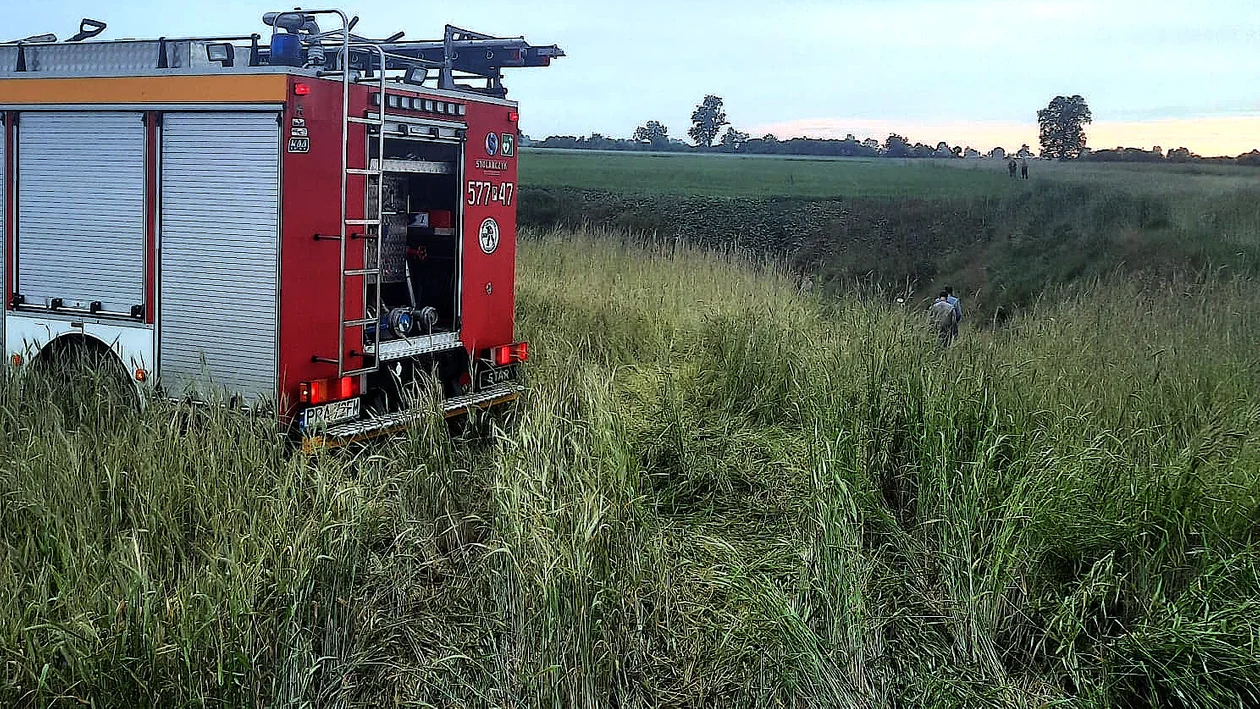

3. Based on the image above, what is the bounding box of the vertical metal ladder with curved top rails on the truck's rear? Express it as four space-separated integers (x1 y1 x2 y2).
295 10 389 377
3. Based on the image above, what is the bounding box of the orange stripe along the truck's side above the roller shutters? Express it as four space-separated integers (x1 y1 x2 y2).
0 74 289 106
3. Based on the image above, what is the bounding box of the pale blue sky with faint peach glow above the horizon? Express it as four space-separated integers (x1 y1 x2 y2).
0 0 1260 151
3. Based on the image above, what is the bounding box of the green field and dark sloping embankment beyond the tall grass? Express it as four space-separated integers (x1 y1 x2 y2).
520 151 1260 316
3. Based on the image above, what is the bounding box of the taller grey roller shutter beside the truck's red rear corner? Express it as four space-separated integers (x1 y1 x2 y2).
158 113 280 400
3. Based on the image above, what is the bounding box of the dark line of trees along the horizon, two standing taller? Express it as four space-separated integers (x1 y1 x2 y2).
520 94 1260 166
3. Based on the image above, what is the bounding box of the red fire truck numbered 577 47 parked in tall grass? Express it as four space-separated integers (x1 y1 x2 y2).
0 10 563 442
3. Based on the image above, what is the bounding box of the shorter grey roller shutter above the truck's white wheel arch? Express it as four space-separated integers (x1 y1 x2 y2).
18 112 145 314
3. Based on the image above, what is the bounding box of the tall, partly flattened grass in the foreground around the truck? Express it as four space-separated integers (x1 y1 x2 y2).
0 230 1260 709
